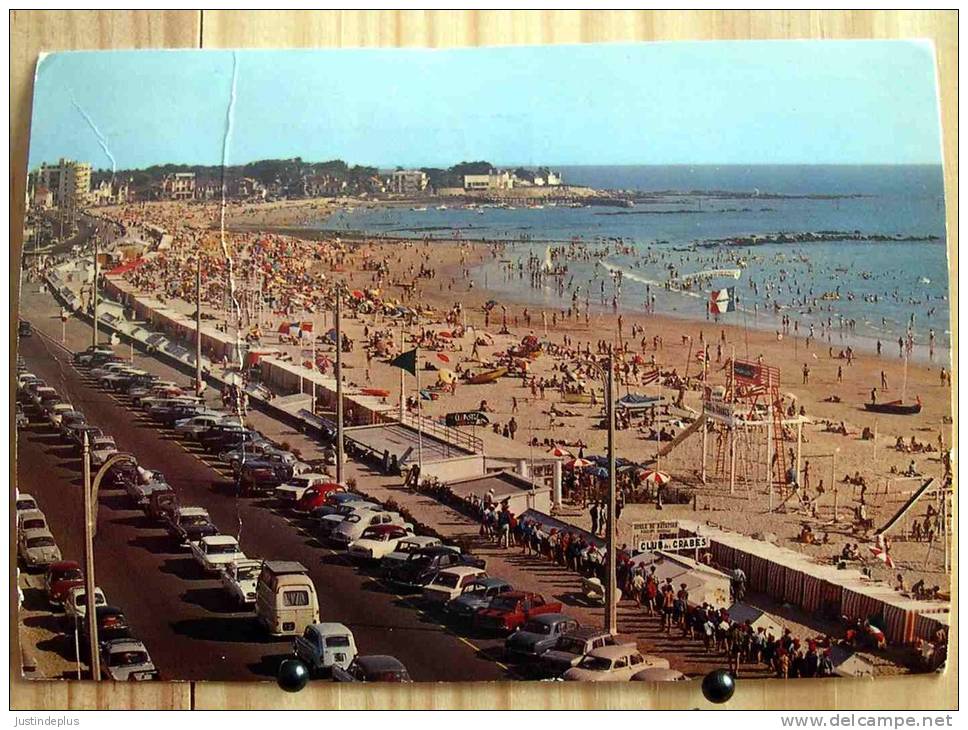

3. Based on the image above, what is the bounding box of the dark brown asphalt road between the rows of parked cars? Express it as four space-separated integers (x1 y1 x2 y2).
18 291 508 681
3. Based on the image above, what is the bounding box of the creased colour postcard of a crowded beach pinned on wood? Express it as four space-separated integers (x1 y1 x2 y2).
12 41 956 684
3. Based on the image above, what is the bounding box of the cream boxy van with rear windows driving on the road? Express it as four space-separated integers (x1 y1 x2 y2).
255 560 319 636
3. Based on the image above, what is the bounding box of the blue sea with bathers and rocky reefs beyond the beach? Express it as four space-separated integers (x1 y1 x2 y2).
316 165 950 362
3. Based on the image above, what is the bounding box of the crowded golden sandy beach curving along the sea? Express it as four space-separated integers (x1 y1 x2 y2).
96 200 952 592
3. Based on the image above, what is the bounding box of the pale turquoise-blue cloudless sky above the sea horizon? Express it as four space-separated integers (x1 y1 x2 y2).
30 41 941 169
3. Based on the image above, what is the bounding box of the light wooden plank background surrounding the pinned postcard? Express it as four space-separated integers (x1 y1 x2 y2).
10 10 958 710
